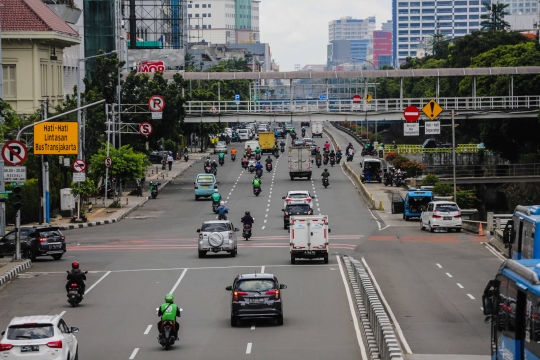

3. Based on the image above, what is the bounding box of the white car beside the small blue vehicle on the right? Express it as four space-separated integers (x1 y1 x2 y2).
420 201 462 232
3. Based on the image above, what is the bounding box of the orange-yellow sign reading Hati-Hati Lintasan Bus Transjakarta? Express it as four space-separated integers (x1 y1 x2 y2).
34 122 79 155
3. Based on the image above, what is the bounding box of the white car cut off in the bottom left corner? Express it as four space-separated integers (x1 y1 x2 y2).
0 315 79 360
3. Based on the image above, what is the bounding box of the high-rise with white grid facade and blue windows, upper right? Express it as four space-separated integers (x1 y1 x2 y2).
392 0 494 67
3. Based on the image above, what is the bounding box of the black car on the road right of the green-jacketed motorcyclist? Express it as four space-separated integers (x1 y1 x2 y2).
225 273 287 326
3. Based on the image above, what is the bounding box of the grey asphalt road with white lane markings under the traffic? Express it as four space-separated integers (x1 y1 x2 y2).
0 122 500 359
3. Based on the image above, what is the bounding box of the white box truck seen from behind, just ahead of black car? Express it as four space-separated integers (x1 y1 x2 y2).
289 215 330 264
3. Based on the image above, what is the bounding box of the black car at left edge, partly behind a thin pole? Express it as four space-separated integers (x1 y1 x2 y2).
0 226 66 260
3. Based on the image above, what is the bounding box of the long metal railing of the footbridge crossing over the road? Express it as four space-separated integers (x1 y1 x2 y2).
185 95 540 114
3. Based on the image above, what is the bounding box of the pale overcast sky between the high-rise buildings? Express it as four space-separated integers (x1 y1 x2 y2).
259 0 392 71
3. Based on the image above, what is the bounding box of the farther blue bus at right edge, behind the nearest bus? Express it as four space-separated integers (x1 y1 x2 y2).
503 205 540 260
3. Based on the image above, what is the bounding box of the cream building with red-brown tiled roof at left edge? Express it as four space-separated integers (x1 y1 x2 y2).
0 0 80 114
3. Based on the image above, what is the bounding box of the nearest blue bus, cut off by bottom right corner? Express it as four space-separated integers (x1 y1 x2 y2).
482 259 540 360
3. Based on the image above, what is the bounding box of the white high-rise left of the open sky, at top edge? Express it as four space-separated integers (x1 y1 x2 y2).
187 0 260 44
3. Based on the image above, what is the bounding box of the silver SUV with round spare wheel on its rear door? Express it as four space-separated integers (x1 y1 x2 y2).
197 220 239 258
